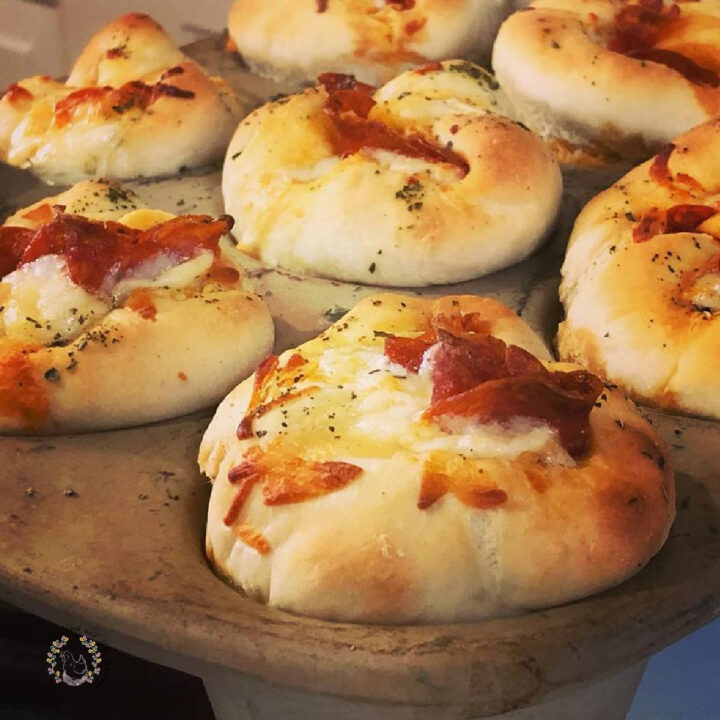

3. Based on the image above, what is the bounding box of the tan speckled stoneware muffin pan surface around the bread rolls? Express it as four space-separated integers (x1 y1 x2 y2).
0 32 720 717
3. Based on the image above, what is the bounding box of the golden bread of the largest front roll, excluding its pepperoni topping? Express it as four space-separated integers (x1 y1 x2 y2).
199 295 674 623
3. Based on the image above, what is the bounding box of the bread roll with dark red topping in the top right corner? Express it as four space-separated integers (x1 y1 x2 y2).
493 0 720 164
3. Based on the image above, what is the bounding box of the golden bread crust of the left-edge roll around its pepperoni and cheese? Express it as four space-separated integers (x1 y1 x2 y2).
0 181 274 433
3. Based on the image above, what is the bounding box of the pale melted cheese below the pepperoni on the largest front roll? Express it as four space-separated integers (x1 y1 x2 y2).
253 345 573 464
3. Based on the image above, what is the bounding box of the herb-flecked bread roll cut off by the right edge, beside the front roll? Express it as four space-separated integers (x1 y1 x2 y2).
558 120 720 418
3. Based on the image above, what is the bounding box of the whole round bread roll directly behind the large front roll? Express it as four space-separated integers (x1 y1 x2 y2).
223 61 562 286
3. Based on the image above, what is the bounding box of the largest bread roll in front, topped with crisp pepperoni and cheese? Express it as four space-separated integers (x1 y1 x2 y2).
199 295 675 623
